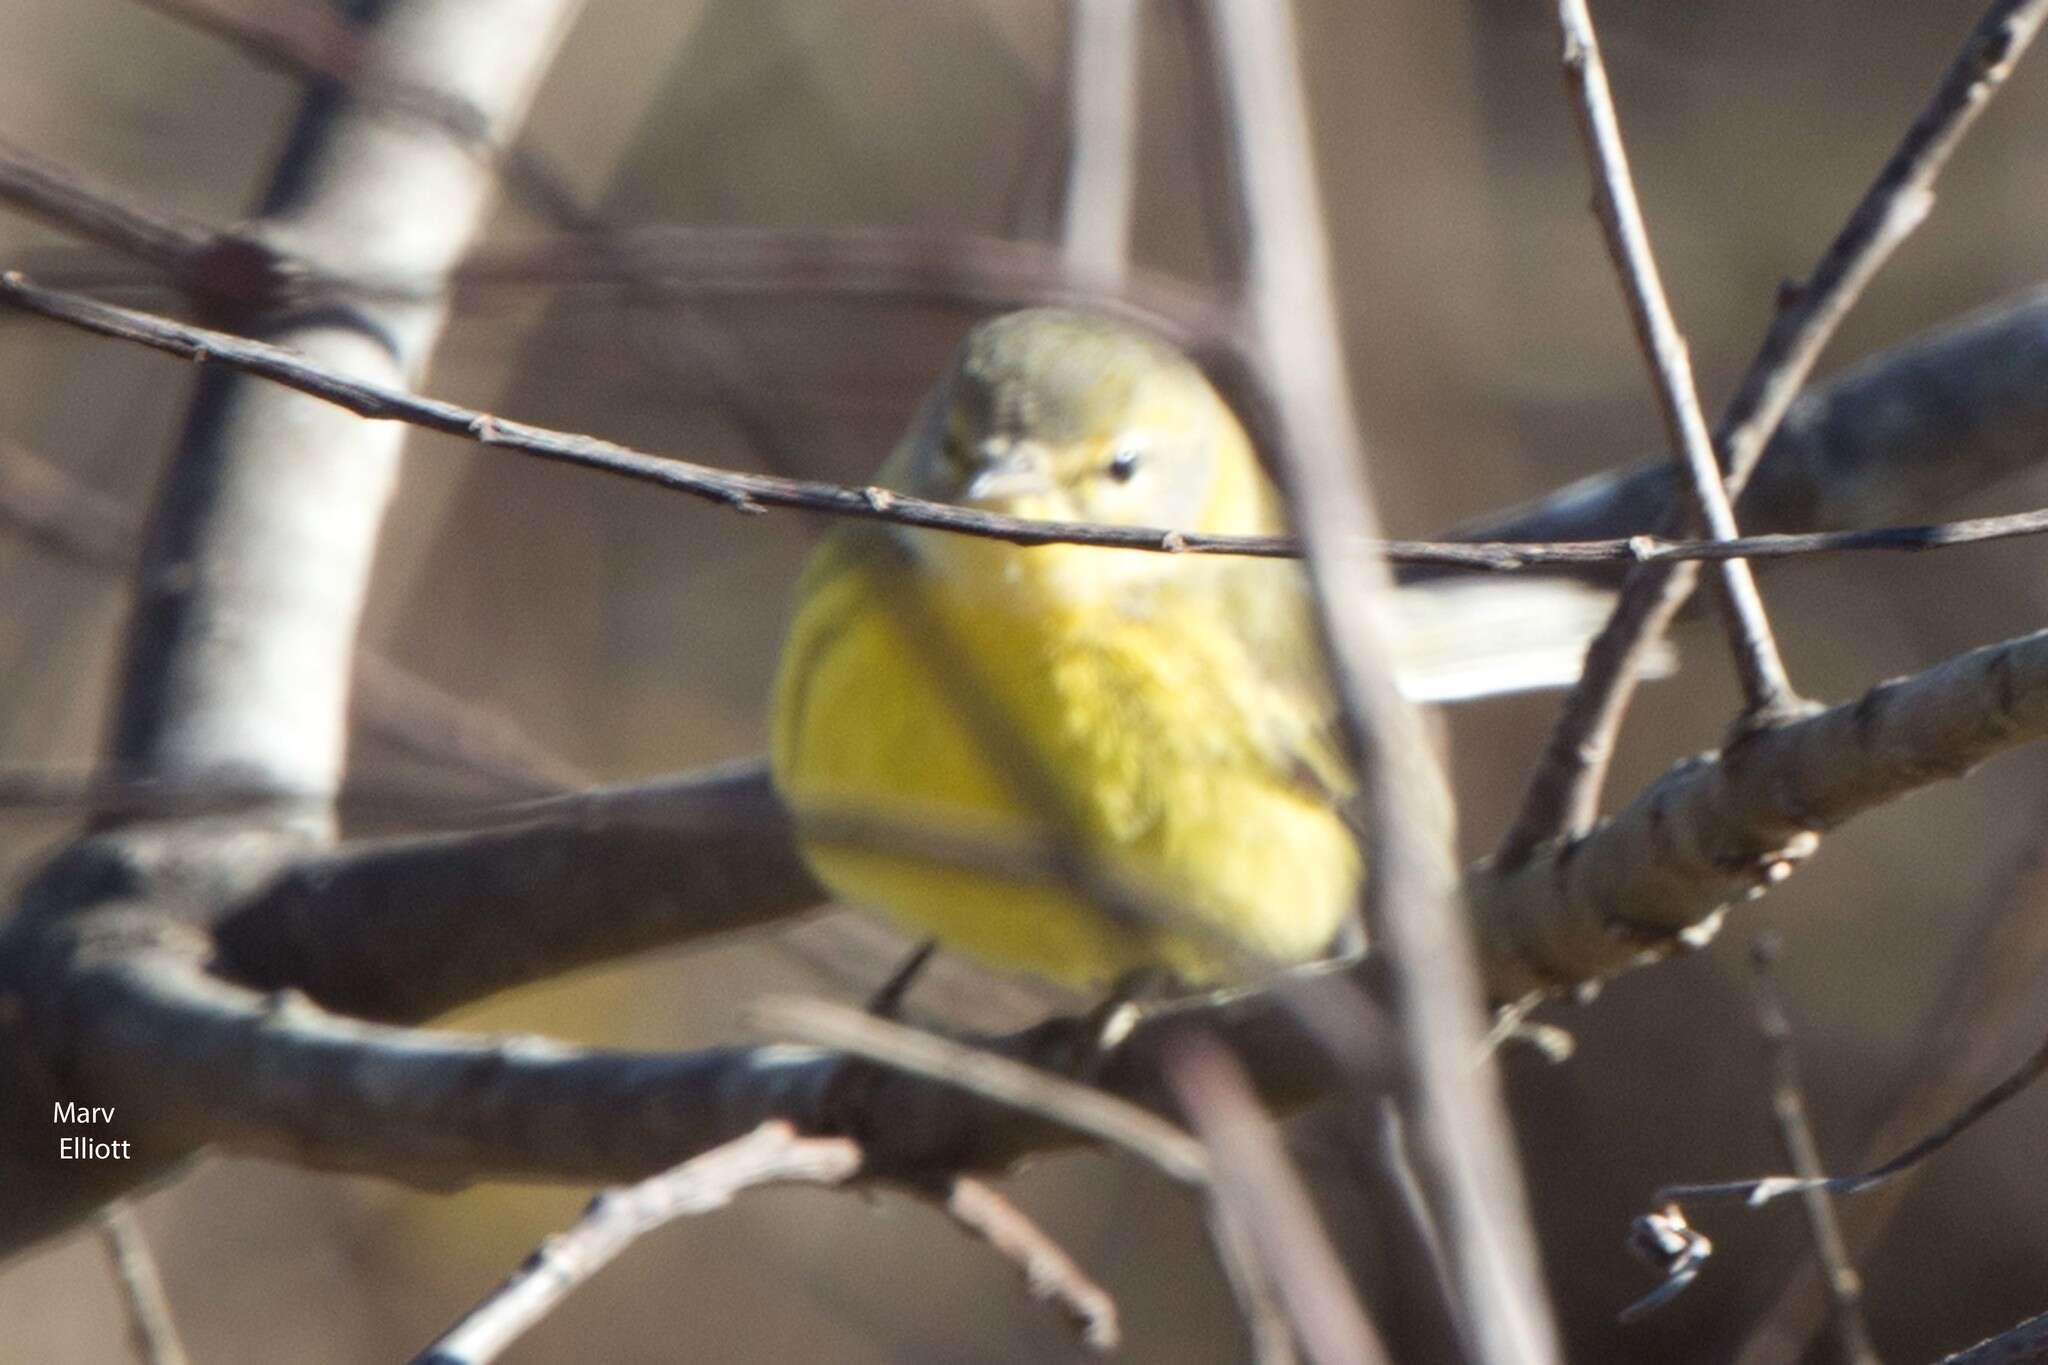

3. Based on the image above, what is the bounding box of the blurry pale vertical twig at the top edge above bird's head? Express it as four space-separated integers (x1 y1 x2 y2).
1059 0 1143 289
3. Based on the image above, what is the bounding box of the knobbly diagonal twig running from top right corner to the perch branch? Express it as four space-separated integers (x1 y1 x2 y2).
1497 0 2048 866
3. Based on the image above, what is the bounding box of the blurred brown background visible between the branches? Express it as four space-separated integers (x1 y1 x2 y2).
0 0 2048 1365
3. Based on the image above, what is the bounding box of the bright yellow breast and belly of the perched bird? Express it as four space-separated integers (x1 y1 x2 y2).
772 548 1358 984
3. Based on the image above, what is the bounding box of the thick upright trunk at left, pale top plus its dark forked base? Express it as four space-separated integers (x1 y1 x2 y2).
0 0 593 1240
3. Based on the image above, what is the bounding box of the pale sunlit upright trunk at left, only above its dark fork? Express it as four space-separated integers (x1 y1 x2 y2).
97 0 585 810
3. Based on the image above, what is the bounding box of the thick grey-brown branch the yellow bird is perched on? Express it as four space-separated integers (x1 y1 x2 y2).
12 609 2048 1246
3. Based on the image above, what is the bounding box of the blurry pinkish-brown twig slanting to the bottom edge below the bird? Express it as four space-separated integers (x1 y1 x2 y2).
1165 1029 1389 1365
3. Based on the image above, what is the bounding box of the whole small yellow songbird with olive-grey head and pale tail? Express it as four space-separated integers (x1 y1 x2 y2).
770 309 1630 986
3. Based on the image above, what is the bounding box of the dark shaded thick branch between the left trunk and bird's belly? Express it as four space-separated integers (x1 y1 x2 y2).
217 765 825 1021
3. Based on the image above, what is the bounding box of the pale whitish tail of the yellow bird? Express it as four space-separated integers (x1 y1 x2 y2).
1395 577 1677 702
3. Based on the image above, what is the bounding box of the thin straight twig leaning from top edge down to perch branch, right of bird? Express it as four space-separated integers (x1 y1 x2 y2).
1556 0 1796 716
